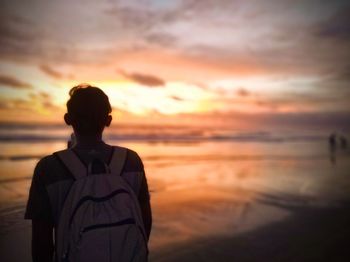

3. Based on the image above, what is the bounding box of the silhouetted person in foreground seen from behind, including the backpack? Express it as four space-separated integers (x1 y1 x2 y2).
25 85 152 262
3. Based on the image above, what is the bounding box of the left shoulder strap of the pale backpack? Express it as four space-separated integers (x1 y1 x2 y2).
54 149 87 179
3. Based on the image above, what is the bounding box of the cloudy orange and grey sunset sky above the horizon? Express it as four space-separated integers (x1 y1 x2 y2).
0 0 350 129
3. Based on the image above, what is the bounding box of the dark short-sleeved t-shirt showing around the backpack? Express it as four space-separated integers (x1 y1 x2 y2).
25 144 149 226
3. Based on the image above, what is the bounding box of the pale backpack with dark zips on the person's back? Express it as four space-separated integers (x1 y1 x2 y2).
56 147 148 262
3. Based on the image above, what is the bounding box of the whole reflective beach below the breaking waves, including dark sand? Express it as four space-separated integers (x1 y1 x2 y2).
0 126 350 261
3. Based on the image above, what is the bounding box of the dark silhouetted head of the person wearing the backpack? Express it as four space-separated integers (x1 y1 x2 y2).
64 84 112 136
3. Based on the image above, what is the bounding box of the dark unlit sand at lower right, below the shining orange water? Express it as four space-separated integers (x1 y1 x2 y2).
151 203 350 262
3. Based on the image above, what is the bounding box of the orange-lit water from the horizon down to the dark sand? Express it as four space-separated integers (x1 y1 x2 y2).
0 124 350 261
